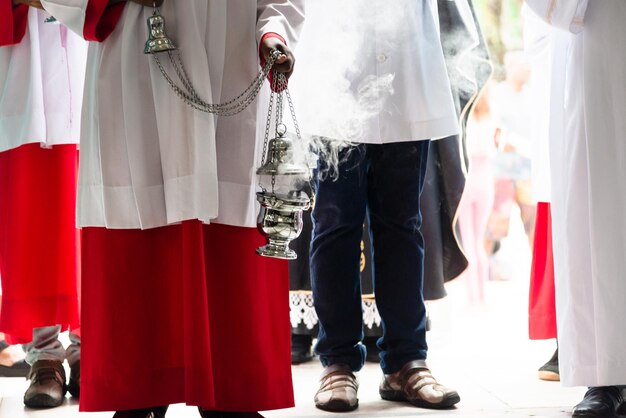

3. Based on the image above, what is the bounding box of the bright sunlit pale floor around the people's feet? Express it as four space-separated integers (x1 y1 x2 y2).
0 212 584 418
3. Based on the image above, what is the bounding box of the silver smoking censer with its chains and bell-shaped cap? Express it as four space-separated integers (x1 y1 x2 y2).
144 4 314 260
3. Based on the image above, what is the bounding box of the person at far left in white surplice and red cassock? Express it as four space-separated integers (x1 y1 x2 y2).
0 0 87 408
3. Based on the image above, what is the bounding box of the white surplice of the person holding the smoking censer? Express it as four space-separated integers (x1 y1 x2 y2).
42 0 304 229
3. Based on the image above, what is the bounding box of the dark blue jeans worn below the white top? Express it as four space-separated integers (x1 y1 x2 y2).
311 141 429 374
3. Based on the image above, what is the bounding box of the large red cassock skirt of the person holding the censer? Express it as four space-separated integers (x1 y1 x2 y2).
80 221 293 411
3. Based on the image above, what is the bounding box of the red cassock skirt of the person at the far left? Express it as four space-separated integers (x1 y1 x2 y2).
0 144 80 343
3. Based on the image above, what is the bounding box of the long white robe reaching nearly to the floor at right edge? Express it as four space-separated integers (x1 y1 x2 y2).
529 0 626 386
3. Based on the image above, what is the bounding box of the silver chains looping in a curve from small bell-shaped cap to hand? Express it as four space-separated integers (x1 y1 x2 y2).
152 50 284 116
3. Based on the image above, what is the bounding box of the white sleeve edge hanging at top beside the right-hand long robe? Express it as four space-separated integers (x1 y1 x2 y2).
526 0 589 33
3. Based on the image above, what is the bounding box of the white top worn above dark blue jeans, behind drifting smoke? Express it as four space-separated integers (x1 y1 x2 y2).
290 0 459 144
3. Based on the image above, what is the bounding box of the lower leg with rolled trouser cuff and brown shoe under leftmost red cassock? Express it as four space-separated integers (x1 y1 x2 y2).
23 325 66 408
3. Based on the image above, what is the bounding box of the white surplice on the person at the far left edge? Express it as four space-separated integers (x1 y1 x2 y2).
0 8 87 152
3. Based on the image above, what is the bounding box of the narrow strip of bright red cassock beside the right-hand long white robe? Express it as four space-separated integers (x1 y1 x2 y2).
528 202 557 340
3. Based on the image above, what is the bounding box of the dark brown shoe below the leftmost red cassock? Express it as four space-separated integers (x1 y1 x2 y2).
24 360 65 408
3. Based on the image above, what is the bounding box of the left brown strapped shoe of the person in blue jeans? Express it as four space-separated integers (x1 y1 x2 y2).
314 364 359 412
